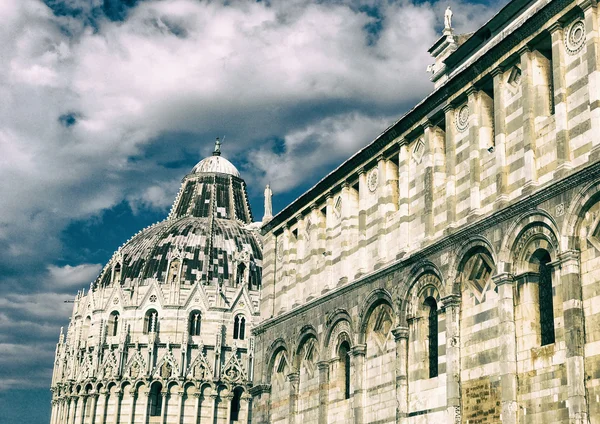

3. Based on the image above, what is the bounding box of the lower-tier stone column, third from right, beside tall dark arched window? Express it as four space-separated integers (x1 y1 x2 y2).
442 294 461 424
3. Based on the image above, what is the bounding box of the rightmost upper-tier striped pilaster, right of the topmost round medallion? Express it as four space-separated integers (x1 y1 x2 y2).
578 0 600 161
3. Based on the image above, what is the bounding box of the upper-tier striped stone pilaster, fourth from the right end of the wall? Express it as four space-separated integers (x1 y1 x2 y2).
492 68 508 209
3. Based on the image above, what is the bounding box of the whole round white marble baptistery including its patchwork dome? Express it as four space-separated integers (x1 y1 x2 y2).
52 140 262 423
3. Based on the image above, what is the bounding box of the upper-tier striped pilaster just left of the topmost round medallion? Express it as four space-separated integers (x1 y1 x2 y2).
549 22 571 177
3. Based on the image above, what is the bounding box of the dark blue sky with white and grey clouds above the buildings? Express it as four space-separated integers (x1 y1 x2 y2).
0 0 506 424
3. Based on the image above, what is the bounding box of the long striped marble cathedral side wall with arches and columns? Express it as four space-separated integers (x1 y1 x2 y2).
250 0 600 424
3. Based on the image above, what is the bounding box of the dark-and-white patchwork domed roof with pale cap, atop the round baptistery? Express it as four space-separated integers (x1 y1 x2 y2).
98 139 262 286
